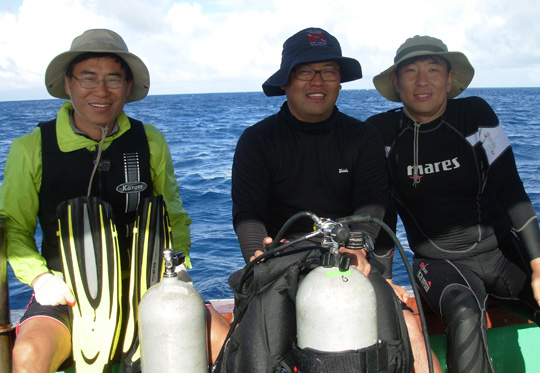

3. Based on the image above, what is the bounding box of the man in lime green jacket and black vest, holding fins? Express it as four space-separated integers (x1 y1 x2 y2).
0 29 196 371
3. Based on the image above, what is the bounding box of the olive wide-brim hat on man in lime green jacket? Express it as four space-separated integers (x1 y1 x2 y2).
45 29 150 102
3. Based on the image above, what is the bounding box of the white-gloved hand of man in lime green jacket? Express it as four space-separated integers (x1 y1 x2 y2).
32 273 75 307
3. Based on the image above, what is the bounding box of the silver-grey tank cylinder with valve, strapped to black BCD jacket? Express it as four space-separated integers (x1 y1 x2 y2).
296 220 378 352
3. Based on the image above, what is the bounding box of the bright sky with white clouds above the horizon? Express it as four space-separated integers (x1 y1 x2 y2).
0 0 540 101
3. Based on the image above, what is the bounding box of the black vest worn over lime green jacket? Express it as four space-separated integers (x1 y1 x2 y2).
38 118 153 271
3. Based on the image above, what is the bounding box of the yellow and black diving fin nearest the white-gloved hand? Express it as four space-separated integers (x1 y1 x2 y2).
57 197 122 373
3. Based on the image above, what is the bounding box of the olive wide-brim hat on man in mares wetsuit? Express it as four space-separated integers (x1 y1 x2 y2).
373 35 474 102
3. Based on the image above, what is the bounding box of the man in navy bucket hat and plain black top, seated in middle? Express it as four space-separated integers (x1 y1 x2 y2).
232 28 412 372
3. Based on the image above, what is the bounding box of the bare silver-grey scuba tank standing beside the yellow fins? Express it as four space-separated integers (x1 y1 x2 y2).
139 248 208 373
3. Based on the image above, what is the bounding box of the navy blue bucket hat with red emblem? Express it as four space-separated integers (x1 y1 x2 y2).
263 28 362 96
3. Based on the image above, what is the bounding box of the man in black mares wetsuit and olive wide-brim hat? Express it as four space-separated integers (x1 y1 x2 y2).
368 36 540 372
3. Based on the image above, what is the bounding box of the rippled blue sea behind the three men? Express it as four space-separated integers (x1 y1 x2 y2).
0 88 540 309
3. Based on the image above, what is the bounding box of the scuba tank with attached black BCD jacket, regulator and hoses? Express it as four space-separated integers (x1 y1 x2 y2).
212 211 420 373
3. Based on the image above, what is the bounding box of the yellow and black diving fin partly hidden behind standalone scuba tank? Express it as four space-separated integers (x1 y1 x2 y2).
122 195 173 373
